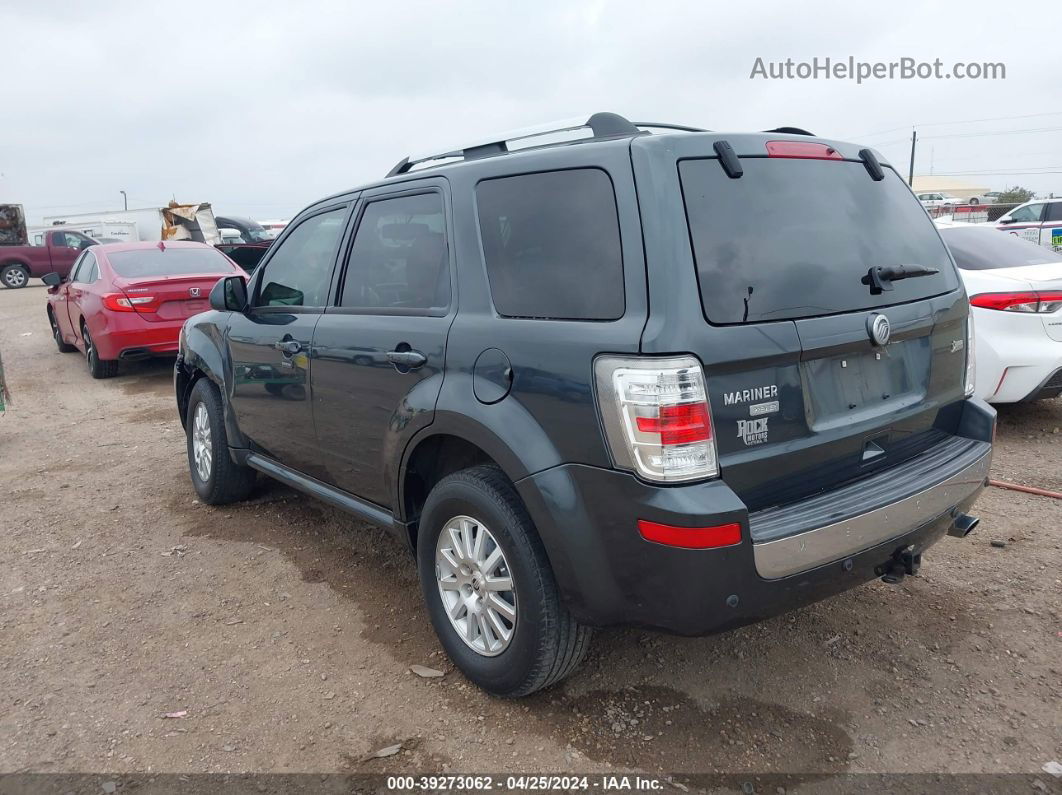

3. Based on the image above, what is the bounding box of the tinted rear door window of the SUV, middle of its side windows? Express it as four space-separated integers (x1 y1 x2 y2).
340 192 450 310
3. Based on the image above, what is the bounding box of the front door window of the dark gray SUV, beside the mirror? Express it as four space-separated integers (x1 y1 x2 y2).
256 207 346 307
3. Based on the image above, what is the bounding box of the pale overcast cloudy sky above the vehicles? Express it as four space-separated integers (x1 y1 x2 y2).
0 0 1062 223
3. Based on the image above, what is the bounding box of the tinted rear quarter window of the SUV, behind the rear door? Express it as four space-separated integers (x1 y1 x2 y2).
476 169 623 321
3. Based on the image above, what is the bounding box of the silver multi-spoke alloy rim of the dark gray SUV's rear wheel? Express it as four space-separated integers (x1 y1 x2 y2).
435 516 517 657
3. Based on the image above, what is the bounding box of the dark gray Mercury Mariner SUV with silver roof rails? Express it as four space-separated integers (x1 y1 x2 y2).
175 114 995 696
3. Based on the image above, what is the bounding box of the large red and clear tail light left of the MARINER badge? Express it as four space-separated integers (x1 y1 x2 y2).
594 357 719 483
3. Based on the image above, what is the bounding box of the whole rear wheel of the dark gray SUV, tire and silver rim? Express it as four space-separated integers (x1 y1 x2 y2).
416 466 590 697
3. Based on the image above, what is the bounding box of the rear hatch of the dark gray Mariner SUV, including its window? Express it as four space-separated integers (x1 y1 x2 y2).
635 135 967 511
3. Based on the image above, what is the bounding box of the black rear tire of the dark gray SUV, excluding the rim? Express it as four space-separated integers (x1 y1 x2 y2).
416 466 592 698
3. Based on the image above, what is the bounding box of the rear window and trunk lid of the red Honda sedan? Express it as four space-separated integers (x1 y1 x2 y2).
108 244 239 323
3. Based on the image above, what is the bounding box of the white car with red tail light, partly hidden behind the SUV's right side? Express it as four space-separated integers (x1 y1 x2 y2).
937 222 1062 403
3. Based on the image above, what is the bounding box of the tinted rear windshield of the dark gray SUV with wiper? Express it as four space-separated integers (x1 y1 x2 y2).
679 157 958 324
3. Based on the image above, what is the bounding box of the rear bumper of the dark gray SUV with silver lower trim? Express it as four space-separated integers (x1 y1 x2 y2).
517 401 994 635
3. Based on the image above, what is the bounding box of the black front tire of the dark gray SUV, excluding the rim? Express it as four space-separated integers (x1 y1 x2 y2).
185 378 256 505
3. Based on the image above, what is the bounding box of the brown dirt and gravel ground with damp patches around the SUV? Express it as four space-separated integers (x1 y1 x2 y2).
0 283 1062 787
